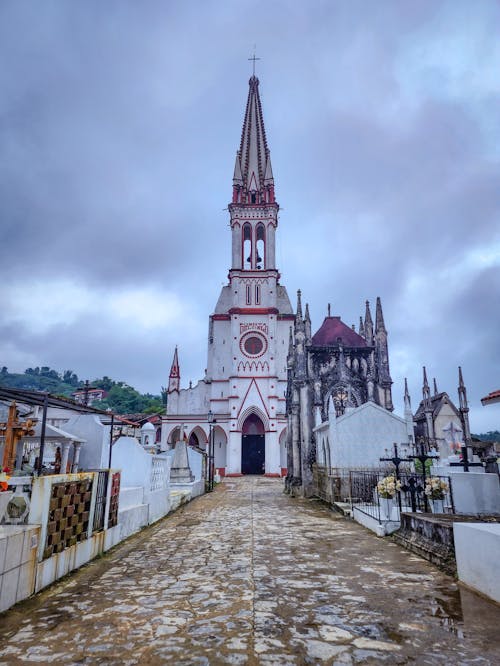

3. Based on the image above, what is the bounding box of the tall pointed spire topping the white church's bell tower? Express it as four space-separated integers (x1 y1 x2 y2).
233 75 274 203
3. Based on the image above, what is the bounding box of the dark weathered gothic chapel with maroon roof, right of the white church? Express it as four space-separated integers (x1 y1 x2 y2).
286 292 394 496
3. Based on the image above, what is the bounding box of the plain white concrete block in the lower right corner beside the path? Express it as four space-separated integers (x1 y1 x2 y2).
453 523 500 603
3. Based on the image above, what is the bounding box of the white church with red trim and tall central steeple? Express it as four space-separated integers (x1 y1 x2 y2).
162 76 295 476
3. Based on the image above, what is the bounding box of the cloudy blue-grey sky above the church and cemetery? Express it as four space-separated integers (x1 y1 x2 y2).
0 0 500 432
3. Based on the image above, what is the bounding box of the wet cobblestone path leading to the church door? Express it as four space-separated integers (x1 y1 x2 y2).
0 477 500 666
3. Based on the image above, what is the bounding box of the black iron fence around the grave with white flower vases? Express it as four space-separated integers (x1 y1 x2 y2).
349 470 455 523
